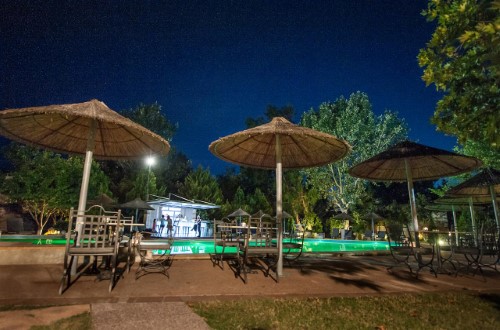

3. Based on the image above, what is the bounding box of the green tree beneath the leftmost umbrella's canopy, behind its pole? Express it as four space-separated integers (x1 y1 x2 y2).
1 143 109 235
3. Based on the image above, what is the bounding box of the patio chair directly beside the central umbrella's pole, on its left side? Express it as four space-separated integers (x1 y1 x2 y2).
237 222 280 284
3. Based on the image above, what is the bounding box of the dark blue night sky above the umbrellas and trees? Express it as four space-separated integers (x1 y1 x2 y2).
0 0 456 174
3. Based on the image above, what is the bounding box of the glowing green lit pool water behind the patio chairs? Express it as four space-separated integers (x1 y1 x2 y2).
0 235 389 254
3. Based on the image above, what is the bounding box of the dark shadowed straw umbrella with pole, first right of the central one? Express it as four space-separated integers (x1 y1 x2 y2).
349 141 481 246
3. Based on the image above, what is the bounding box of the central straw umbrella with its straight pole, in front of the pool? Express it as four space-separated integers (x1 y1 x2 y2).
209 117 350 276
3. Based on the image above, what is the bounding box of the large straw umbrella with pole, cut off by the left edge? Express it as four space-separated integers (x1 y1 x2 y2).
0 100 170 237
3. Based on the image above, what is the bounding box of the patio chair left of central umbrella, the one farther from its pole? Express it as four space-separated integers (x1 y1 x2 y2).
210 220 243 269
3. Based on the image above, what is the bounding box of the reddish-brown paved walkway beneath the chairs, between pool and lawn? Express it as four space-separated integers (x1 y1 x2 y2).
0 256 500 329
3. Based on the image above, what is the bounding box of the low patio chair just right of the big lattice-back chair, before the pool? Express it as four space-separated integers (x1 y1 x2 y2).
135 233 173 280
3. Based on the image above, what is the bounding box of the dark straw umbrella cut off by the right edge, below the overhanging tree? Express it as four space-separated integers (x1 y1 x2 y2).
446 168 500 230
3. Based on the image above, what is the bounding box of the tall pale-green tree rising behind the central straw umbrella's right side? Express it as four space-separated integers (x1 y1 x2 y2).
302 92 408 217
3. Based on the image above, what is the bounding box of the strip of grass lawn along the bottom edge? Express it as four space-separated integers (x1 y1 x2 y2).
0 292 500 330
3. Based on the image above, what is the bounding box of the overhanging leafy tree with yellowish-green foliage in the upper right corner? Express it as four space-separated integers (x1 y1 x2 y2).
418 0 500 148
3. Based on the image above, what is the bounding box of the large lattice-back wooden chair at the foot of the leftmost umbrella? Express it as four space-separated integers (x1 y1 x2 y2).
59 206 123 294
